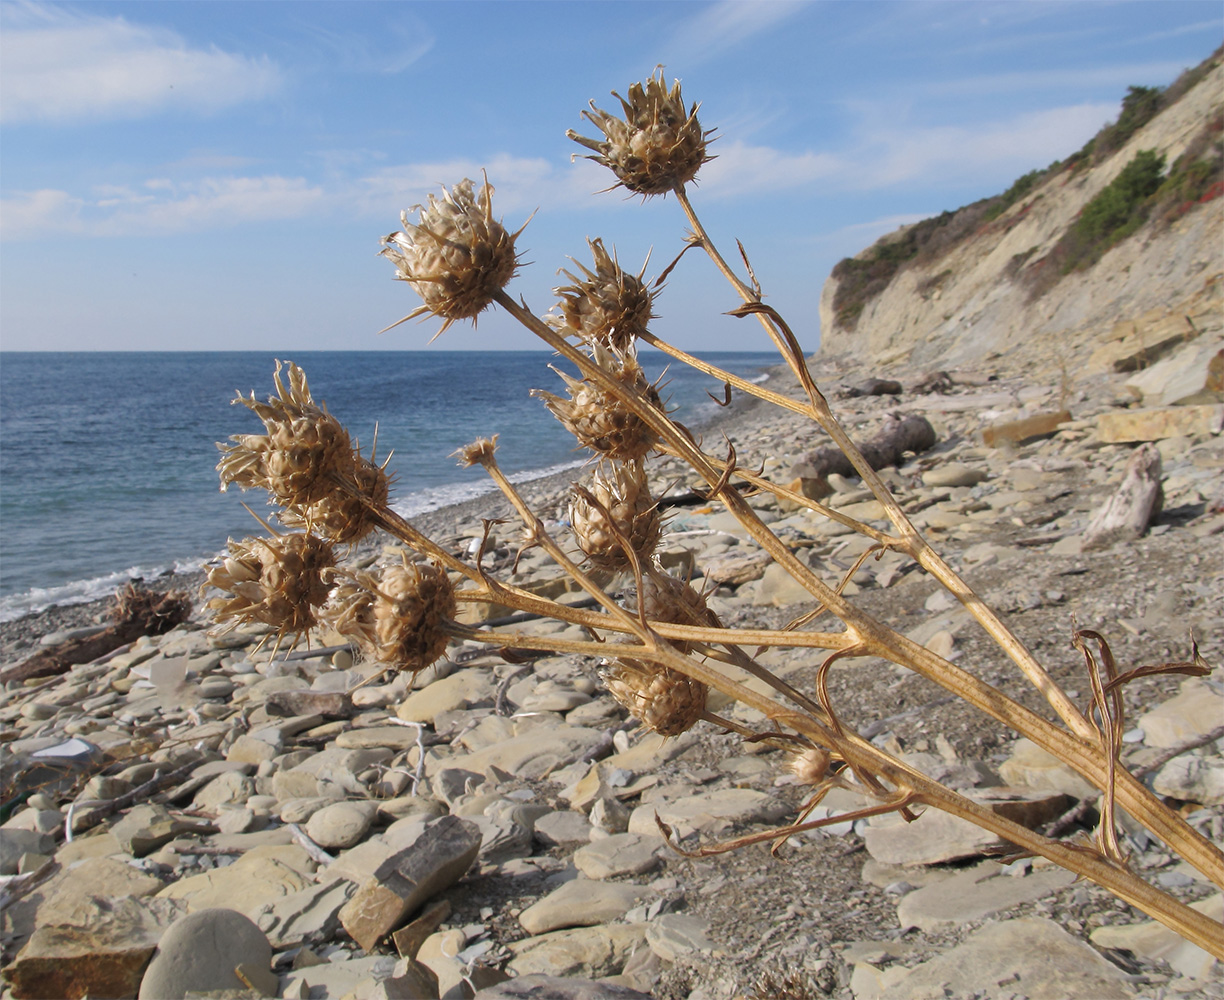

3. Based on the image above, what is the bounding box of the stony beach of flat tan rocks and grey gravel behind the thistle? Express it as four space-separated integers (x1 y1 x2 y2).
0 350 1224 1000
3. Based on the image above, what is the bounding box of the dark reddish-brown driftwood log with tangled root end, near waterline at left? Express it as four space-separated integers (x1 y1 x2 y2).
0 584 191 684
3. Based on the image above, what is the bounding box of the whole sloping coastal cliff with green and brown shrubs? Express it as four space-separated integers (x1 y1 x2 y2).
820 50 1224 371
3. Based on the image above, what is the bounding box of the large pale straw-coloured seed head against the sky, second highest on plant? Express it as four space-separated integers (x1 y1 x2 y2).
381 177 523 333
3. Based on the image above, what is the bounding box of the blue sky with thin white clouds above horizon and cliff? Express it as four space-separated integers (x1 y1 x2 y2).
0 0 1224 351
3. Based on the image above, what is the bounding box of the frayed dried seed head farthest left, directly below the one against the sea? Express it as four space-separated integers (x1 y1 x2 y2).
204 535 335 636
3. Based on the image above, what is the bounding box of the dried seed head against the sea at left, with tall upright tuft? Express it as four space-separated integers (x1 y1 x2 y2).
217 361 355 508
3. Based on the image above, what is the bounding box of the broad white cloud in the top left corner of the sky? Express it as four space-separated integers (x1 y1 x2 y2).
0 2 280 124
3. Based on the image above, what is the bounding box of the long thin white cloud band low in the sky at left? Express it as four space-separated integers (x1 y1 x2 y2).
0 176 323 240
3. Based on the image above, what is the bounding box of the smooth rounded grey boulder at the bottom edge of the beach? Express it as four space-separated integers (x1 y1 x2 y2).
140 908 277 1000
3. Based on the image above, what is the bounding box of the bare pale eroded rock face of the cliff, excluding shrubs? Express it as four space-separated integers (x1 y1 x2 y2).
820 65 1224 373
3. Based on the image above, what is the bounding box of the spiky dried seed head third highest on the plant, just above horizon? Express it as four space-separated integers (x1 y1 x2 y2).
545 240 654 351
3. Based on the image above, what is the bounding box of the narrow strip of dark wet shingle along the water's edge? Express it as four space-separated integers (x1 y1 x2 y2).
0 359 798 663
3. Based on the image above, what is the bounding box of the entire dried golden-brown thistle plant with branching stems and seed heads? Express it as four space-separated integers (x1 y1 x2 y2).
211 73 1224 958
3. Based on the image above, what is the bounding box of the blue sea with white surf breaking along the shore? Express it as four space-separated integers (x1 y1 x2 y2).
0 351 778 622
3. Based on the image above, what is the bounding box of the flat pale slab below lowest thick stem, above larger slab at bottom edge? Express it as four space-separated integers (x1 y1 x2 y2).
897 862 1075 931
